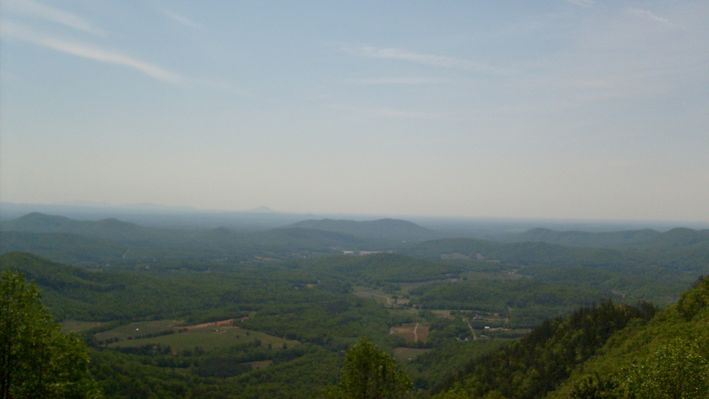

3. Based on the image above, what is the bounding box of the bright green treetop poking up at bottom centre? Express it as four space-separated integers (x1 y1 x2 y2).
325 337 412 399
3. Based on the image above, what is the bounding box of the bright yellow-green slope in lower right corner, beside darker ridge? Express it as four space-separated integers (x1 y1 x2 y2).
548 277 709 399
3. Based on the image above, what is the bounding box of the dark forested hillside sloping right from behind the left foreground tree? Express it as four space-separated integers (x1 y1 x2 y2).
0 252 232 320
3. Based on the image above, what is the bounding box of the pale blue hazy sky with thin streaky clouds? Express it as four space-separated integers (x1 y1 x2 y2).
0 0 709 221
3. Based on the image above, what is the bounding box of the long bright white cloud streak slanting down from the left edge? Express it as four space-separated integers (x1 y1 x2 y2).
0 22 182 83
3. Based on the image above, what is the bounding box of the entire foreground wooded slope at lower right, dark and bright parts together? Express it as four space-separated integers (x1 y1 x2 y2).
437 278 709 399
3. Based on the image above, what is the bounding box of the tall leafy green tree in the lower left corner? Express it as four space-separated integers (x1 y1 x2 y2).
0 271 101 399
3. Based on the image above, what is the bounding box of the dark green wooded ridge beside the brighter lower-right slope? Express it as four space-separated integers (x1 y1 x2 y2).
436 302 655 399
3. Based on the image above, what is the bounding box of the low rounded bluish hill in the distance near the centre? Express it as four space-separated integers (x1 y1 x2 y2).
292 219 436 241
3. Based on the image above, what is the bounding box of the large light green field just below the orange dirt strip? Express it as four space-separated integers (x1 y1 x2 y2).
109 326 299 352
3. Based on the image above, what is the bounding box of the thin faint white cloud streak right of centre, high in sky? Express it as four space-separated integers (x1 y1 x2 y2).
342 46 510 74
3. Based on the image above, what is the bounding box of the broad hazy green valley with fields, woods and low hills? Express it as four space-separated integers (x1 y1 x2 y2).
0 214 709 398
